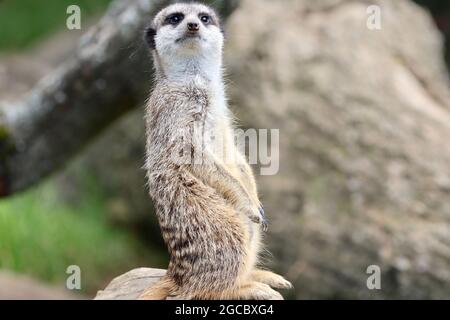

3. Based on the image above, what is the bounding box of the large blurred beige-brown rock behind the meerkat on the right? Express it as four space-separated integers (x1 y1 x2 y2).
226 0 450 299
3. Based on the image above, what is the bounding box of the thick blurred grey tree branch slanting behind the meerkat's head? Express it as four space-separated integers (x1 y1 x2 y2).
0 0 237 196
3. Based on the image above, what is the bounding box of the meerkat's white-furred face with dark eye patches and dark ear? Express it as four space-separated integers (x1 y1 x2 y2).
146 3 223 57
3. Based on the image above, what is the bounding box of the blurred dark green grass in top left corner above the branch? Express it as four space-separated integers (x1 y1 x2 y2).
0 0 111 51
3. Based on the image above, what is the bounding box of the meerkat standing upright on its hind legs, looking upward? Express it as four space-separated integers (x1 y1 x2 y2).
139 3 292 300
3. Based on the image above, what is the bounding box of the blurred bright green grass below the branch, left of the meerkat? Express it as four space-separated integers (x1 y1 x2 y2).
0 177 162 293
